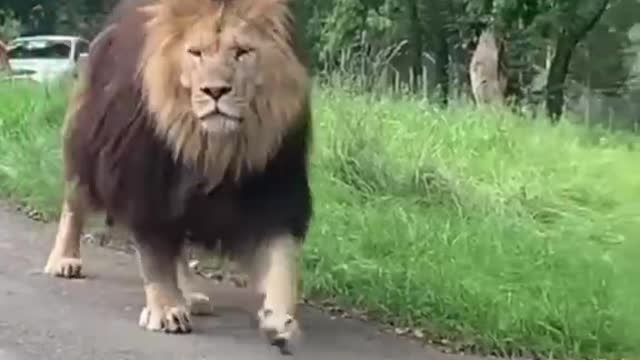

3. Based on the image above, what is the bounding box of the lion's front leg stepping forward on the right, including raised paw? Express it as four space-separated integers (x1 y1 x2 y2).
251 235 302 353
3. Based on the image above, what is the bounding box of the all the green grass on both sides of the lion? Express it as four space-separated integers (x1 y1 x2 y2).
0 80 640 359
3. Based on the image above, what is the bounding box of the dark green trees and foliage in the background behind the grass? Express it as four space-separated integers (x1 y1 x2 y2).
0 0 640 126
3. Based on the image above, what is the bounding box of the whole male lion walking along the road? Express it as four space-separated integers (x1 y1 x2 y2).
44 0 312 351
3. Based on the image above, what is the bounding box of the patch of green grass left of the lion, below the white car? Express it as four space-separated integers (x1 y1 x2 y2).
0 82 67 212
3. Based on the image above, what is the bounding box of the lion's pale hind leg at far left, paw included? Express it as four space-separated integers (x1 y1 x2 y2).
44 184 89 278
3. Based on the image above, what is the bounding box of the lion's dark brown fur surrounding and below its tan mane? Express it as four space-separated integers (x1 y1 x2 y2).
65 0 312 253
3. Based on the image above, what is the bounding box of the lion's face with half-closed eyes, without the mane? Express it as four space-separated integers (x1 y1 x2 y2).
180 20 262 133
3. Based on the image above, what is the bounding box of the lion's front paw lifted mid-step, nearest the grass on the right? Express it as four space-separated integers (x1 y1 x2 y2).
258 309 302 355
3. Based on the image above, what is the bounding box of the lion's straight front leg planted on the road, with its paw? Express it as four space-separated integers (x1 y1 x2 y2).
136 235 191 333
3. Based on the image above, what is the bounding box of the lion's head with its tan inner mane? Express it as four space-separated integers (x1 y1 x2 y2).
140 0 310 181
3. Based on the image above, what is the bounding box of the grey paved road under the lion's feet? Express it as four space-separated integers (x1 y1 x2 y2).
0 206 482 360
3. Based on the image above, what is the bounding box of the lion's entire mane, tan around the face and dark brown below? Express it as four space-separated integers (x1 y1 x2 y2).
64 0 311 255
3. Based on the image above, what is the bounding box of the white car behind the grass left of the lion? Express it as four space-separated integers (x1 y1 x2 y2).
8 35 89 82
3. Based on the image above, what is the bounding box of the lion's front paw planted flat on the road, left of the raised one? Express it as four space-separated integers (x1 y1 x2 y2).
139 306 191 333
